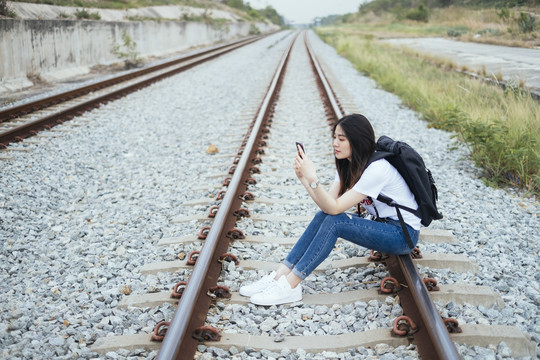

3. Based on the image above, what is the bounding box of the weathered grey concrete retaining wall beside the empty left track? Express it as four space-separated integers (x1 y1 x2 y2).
0 19 275 92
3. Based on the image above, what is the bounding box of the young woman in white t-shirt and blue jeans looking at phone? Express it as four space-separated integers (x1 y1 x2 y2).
240 114 420 306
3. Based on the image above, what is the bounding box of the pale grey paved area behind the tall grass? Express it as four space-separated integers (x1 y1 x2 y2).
386 38 540 93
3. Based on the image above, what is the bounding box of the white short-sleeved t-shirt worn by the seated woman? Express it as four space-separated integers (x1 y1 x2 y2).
335 159 420 230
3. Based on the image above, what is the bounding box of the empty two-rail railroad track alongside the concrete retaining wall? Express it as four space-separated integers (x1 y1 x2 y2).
0 35 267 149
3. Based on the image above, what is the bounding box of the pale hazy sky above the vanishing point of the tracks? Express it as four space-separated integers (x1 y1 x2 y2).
248 0 365 24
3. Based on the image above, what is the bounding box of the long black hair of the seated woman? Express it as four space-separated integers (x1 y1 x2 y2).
332 114 376 195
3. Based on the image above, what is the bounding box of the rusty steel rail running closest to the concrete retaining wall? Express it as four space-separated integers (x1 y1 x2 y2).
0 36 262 123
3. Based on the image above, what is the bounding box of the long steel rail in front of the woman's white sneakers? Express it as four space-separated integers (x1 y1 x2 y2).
157 31 297 360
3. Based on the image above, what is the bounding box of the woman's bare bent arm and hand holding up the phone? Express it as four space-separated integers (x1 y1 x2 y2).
293 149 366 215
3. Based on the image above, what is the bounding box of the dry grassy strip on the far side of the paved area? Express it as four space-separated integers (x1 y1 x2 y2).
338 5 540 48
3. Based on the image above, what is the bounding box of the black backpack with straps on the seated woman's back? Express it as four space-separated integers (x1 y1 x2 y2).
366 136 443 249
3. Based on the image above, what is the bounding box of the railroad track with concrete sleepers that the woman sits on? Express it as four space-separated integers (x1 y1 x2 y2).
81 31 530 359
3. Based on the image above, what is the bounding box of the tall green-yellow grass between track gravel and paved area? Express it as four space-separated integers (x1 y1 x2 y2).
317 26 540 195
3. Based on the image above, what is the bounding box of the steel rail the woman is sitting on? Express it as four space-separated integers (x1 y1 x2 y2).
304 34 460 360
